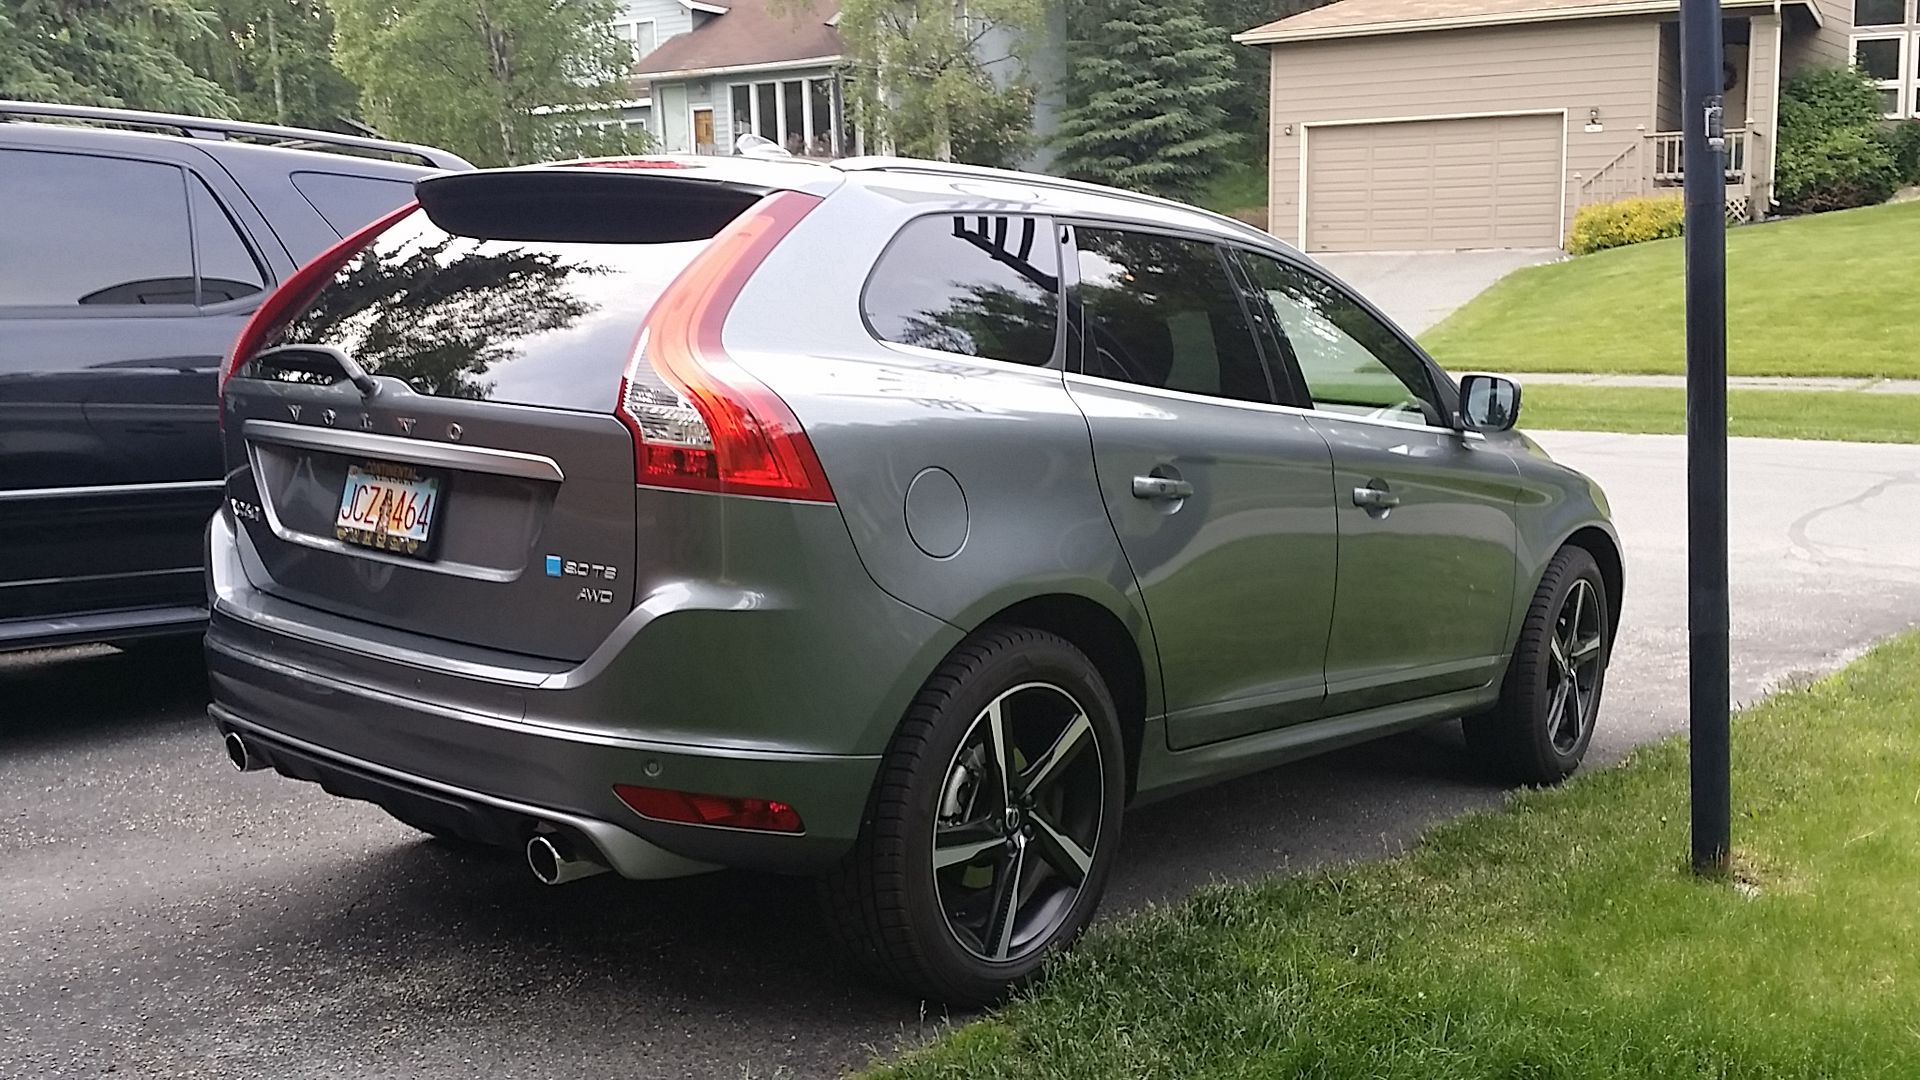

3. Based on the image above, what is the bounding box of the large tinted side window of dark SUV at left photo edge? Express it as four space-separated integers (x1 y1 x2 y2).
0 150 194 306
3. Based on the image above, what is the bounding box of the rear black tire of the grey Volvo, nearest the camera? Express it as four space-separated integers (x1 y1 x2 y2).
820 626 1125 1007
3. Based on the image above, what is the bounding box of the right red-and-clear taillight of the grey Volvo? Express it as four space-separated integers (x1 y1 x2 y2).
616 192 833 502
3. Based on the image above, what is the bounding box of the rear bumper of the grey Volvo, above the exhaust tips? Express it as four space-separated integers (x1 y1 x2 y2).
207 615 879 878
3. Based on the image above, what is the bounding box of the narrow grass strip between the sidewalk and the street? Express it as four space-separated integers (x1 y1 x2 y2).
1521 384 1920 442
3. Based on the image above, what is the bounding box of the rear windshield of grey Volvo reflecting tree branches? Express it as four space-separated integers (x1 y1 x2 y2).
267 211 707 411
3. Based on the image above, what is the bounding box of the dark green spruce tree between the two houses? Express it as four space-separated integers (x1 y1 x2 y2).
1054 0 1236 198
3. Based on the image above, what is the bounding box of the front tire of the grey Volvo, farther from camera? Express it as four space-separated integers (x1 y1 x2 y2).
1463 546 1613 784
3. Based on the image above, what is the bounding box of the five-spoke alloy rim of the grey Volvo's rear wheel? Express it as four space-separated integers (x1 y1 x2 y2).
931 682 1106 963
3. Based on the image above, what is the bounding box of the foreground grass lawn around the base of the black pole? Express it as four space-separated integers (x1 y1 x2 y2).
872 636 1920 1080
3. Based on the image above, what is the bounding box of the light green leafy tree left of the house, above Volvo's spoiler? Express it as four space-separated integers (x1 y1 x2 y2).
334 0 652 165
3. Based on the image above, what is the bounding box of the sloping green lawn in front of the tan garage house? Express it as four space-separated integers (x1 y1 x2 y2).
1423 202 1920 379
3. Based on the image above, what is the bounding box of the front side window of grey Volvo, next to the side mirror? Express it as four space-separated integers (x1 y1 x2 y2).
1244 254 1440 425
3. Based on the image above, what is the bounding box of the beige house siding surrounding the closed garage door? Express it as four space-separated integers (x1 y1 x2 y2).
1269 17 1659 242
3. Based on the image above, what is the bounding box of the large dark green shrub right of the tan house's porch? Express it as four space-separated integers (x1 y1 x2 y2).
1774 67 1899 213
